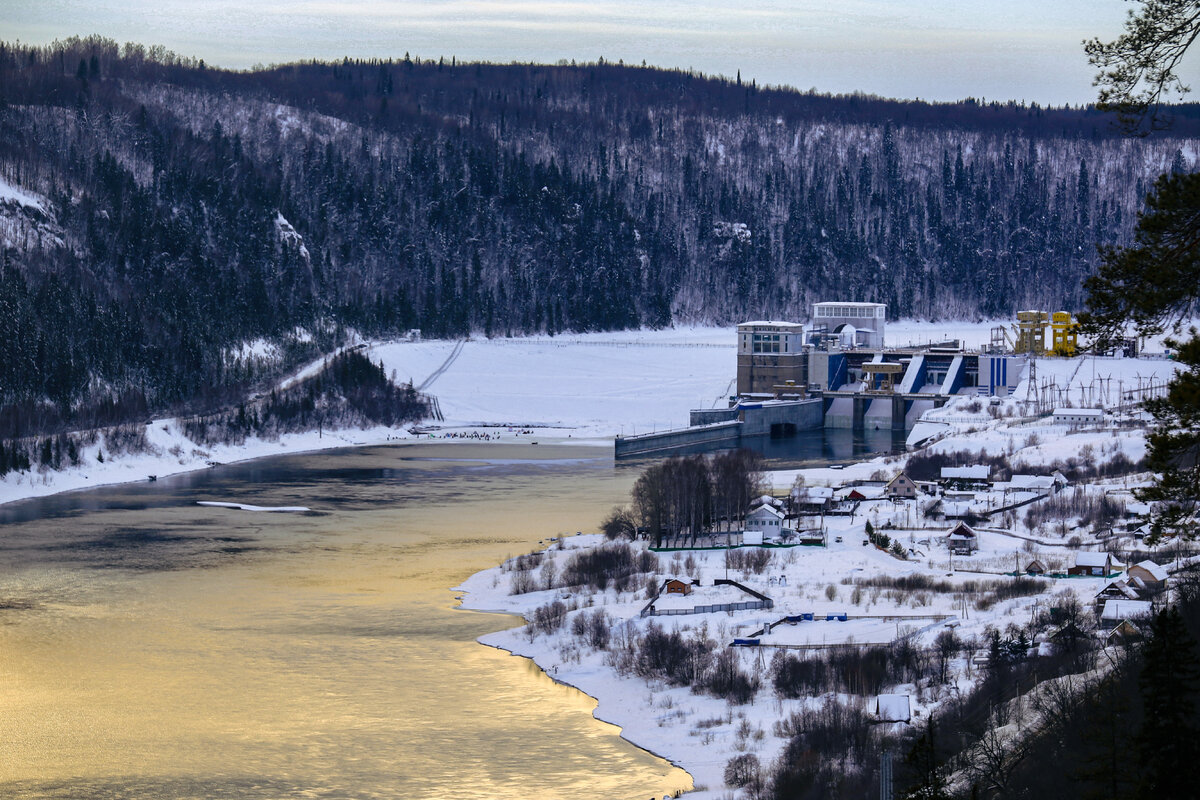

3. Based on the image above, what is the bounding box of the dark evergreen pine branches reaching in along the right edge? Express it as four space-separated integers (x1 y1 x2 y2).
1081 0 1200 539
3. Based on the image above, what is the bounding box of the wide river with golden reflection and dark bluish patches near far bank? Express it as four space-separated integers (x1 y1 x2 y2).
0 445 690 800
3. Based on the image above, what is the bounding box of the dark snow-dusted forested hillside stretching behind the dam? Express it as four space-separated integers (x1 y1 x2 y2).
0 38 1200 437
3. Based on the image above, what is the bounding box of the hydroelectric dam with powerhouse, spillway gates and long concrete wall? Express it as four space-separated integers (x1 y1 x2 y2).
614 302 1027 457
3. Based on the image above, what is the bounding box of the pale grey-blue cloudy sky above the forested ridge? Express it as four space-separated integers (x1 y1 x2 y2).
0 0 1180 106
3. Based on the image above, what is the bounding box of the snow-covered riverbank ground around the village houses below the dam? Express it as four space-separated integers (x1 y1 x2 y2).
455 345 1178 800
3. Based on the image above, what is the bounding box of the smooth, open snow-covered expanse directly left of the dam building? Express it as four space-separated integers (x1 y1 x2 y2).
371 327 736 438
